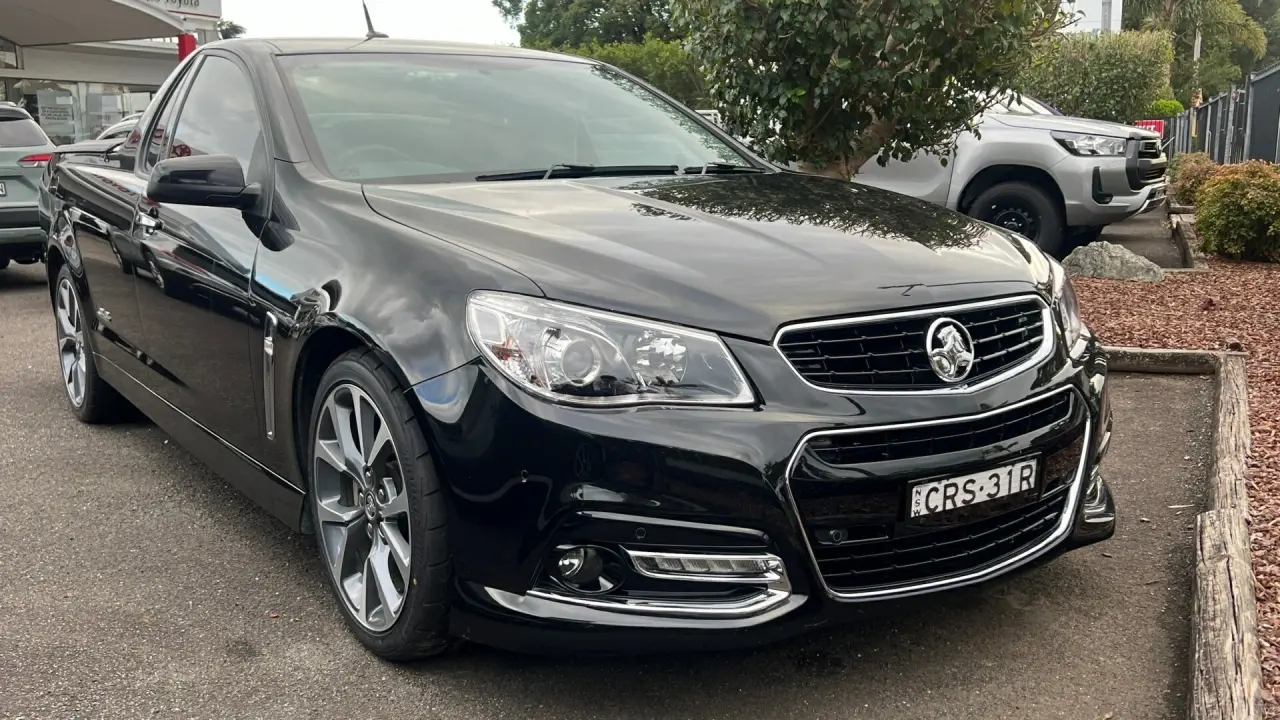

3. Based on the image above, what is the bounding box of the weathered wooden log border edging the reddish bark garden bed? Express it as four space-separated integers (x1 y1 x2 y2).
1106 347 1263 720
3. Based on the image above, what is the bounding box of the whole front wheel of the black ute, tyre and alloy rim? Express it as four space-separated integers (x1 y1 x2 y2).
308 350 452 661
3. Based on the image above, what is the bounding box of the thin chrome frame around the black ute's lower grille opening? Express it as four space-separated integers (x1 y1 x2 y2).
782 384 1093 602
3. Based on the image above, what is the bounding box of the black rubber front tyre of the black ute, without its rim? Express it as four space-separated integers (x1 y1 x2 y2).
305 350 454 662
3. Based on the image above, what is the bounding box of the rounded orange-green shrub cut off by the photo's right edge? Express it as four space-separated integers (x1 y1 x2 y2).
1196 160 1280 261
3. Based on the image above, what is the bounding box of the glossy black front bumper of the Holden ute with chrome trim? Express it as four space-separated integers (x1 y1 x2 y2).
413 342 1115 652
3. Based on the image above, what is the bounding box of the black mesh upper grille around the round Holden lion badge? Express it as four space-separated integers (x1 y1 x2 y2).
776 297 1051 391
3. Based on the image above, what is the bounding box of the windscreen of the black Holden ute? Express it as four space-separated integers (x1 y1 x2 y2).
280 54 750 182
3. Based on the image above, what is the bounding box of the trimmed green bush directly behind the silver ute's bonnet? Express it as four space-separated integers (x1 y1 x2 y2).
1021 32 1174 123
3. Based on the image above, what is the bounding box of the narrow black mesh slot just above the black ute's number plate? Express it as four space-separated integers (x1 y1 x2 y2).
808 392 1073 466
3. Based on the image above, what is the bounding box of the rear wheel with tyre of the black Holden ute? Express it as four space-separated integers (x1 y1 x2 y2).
54 266 133 424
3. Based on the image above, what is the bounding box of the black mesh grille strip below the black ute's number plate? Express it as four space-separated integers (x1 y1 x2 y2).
814 488 1068 592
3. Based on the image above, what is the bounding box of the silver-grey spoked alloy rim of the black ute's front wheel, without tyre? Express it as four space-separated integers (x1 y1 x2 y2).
312 383 412 632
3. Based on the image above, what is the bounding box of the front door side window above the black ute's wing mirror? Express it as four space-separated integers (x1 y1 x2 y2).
169 55 262 177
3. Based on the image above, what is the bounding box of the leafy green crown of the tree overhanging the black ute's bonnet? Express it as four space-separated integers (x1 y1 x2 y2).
672 0 1066 179
